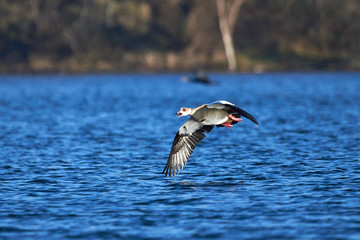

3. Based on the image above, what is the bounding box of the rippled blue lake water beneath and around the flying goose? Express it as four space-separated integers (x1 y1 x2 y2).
0 73 360 239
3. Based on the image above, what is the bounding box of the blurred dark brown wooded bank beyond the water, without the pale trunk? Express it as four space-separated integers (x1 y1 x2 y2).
0 0 360 73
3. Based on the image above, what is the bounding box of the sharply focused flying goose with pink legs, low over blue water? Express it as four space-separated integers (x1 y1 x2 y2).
162 100 259 177
